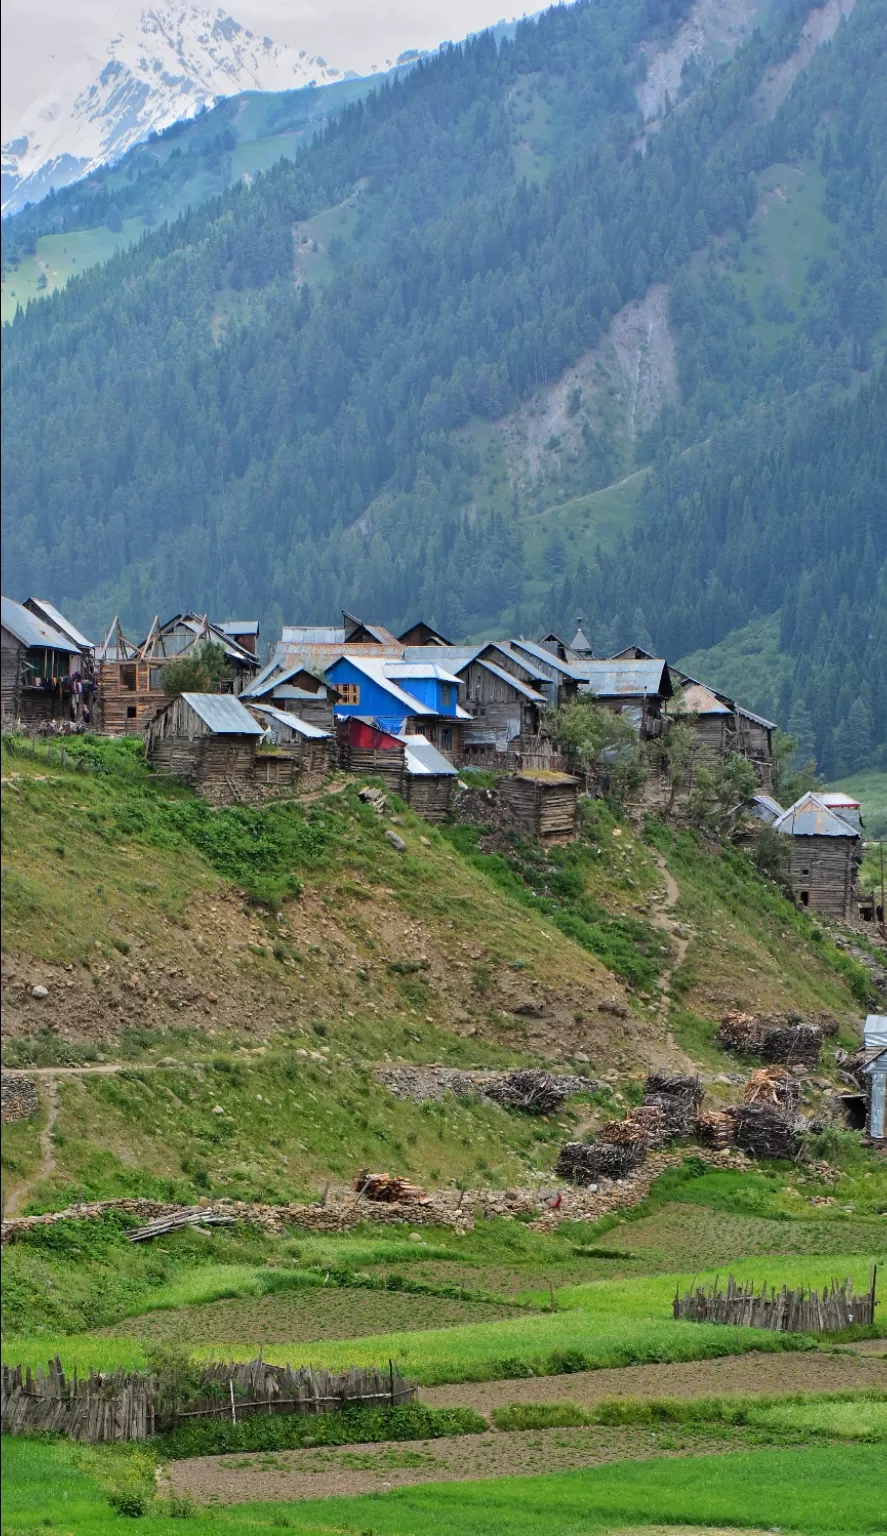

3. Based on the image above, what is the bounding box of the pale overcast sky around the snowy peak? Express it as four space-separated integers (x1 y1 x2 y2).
0 0 525 140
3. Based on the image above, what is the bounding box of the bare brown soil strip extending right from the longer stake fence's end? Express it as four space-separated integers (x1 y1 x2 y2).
421 1350 887 1413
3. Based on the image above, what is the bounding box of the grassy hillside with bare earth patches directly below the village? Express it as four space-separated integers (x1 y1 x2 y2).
3 740 864 1204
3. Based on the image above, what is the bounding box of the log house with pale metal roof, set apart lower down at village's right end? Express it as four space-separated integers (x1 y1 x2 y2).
773 793 862 917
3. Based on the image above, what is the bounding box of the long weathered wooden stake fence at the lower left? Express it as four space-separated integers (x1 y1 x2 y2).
0 1356 417 1442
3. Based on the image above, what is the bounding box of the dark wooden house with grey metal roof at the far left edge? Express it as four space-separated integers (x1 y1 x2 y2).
0 598 86 731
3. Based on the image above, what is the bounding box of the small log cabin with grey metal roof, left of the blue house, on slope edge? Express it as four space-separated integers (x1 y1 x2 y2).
146 693 262 803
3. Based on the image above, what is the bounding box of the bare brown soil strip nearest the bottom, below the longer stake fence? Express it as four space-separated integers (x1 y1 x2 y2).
168 1424 747 1504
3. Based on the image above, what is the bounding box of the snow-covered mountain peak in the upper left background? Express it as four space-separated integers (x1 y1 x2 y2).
2 5 343 214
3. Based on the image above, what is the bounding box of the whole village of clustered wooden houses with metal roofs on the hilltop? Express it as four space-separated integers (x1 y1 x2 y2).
2 598 878 920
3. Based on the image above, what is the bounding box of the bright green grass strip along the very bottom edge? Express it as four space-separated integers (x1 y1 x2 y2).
3 1439 887 1536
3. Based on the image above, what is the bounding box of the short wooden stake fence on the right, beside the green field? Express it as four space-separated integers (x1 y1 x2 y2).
673 1269 878 1333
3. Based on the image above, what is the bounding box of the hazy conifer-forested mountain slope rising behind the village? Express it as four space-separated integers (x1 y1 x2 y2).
5 0 887 768
